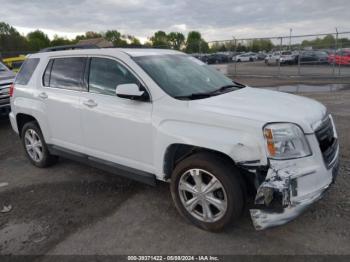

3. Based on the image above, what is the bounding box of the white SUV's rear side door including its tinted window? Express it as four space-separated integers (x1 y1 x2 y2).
38 57 87 151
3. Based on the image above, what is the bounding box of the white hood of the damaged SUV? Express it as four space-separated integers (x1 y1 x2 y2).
190 87 326 133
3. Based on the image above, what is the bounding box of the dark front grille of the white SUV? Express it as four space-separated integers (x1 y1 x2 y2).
315 116 338 168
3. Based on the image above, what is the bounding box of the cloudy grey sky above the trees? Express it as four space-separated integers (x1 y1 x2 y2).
0 0 350 42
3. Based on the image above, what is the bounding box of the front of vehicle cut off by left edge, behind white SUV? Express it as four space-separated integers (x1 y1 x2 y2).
0 62 15 114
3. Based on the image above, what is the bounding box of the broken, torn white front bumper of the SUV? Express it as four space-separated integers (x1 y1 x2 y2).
250 136 339 230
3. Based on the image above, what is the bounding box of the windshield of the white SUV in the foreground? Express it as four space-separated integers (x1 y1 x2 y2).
134 55 241 97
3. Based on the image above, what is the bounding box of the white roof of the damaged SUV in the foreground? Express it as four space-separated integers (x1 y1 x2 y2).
31 48 183 57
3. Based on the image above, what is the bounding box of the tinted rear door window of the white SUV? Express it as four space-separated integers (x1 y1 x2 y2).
43 57 87 91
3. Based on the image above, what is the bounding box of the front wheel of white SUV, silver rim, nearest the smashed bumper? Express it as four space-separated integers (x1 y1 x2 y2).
170 153 245 232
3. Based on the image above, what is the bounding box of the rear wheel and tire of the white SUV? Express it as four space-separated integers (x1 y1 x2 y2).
21 122 58 168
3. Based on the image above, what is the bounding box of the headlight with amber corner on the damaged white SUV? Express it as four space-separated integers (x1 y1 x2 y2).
264 123 311 159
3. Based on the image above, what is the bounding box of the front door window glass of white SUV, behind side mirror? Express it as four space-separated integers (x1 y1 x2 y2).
89 57 139 95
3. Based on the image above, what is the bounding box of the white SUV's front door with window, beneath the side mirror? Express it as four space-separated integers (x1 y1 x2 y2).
81 57 153 172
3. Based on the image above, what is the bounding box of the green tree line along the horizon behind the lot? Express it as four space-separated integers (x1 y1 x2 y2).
0 22 350 57
